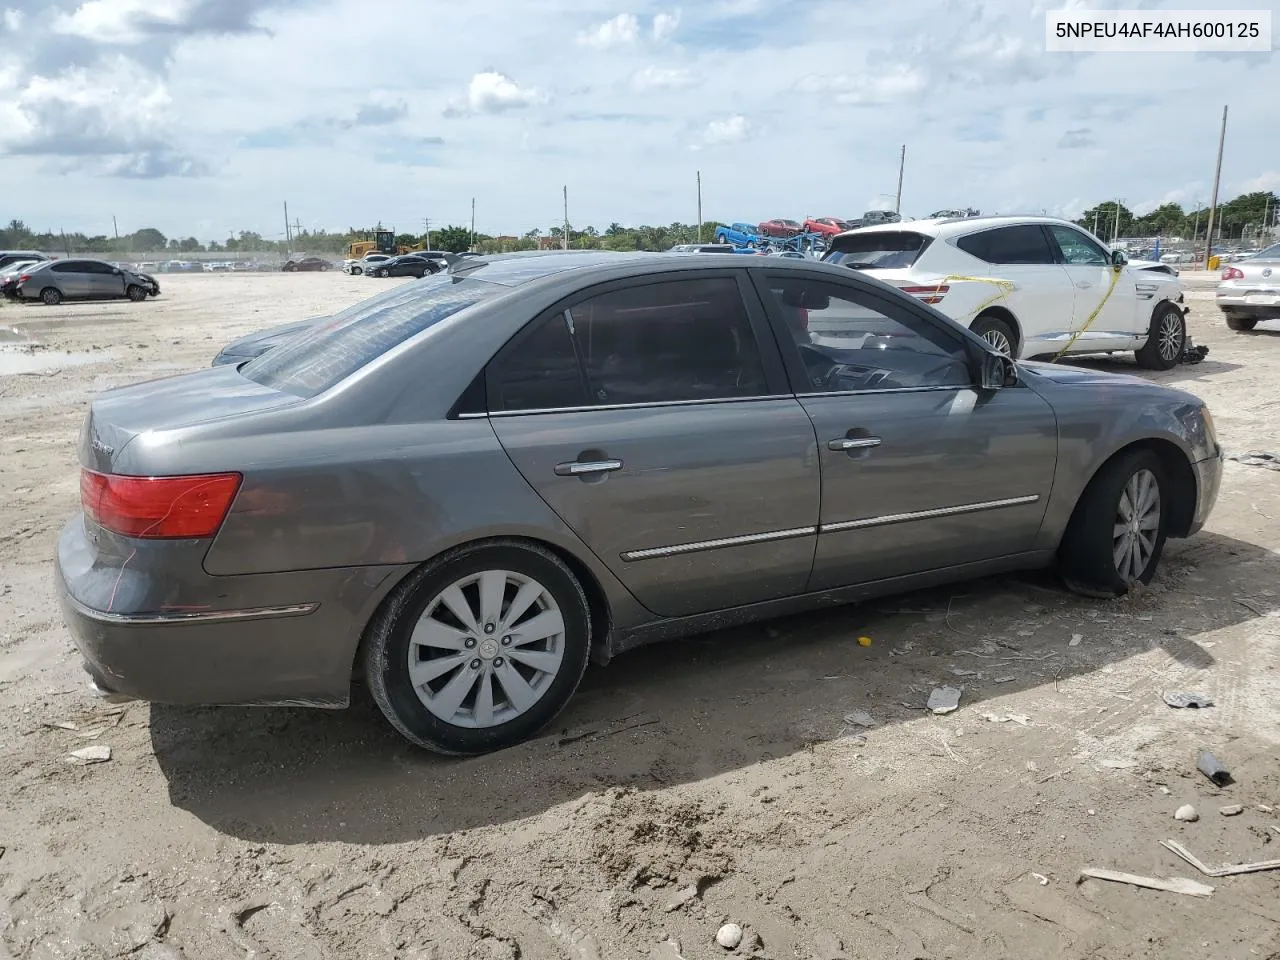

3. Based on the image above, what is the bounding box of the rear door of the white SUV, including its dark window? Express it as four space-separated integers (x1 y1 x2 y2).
954 223 1074 357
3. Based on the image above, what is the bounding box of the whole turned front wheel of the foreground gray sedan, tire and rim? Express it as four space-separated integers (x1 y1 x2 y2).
1059 449 1167 598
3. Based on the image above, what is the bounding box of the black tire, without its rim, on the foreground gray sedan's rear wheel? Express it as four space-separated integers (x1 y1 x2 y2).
361 540 591 756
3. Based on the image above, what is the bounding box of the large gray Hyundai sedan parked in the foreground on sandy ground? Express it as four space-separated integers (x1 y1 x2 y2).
56 253 1221 754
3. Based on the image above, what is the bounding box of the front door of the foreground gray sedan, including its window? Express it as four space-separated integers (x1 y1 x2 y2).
758 271 1057 590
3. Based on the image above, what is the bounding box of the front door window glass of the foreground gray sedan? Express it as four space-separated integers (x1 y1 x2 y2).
768 274 973 393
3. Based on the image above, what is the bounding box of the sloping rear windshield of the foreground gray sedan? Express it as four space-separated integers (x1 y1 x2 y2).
241 274 507 398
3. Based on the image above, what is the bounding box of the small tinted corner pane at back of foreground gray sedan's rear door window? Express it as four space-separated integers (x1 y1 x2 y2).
489 314 588 410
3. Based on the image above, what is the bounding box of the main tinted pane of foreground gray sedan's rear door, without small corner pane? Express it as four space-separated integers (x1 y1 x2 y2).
570 278 767 404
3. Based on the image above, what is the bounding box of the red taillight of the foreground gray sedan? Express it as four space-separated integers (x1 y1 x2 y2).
81 470 242 540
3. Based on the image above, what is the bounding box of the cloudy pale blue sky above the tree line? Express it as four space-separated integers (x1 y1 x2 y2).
0 0 1280 241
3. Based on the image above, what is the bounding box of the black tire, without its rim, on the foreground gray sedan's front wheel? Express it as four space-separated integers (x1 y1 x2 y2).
1057 449 1171 599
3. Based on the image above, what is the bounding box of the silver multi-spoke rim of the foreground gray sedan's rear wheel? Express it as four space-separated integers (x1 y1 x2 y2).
408 570 564 727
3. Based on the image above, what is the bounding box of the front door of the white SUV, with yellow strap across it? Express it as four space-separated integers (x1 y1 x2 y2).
1048 224 1151 349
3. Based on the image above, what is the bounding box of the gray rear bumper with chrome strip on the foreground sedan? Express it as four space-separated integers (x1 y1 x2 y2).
55 517 398 707
